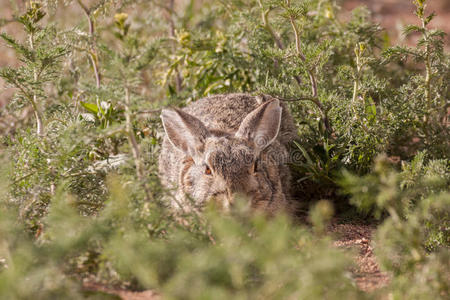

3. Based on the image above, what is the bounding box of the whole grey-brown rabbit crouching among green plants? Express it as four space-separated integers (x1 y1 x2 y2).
159 94 297 215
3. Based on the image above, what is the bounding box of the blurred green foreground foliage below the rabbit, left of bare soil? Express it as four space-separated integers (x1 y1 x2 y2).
0 170 362 299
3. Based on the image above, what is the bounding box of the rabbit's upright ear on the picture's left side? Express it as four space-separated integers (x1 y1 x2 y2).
161 109 209 160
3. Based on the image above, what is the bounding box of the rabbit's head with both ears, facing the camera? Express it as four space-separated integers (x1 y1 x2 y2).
161 100 282 209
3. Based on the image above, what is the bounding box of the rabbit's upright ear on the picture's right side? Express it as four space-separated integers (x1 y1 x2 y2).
236 100 281 151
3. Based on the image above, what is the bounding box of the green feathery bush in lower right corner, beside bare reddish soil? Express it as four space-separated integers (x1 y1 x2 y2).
342 153 450 299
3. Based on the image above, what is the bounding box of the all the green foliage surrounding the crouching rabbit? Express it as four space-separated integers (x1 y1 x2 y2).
0 0 450 299
